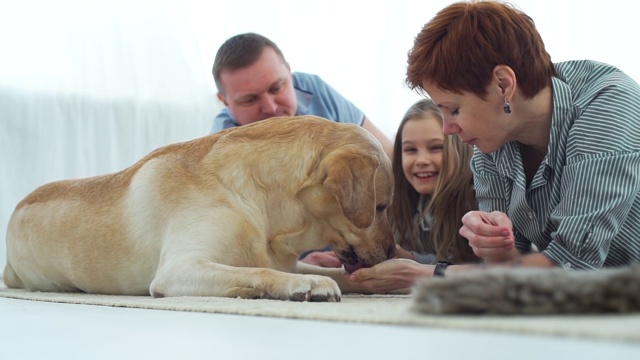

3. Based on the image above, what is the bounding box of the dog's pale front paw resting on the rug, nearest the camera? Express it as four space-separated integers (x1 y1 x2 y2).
286 275 341 302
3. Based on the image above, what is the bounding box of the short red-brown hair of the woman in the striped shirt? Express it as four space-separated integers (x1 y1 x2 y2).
405 1 555 99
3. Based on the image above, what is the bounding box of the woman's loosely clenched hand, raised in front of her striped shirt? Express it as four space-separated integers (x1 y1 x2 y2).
460 211 520 263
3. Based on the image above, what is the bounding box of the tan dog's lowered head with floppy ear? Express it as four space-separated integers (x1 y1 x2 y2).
299 127 395 271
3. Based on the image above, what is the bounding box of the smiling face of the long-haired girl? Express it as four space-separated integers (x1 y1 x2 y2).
401 115 444 195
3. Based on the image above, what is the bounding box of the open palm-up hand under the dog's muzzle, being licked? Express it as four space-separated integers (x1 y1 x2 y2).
347 258 434 294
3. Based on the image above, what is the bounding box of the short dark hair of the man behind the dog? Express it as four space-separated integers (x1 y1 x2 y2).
212 33 287 93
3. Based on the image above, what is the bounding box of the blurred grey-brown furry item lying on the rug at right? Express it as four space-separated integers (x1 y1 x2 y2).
413 265 640 314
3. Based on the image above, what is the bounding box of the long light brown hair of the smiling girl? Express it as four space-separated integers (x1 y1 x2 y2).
389 99 479 262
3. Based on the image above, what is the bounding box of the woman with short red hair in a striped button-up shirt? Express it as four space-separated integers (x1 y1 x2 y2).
406 1 640 271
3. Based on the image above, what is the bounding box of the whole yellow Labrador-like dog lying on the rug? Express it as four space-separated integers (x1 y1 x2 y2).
4 116 395 301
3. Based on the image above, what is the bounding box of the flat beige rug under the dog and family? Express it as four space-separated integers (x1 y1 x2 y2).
0 285 640 343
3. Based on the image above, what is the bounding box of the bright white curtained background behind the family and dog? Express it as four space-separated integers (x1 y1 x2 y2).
0 0 640 270
